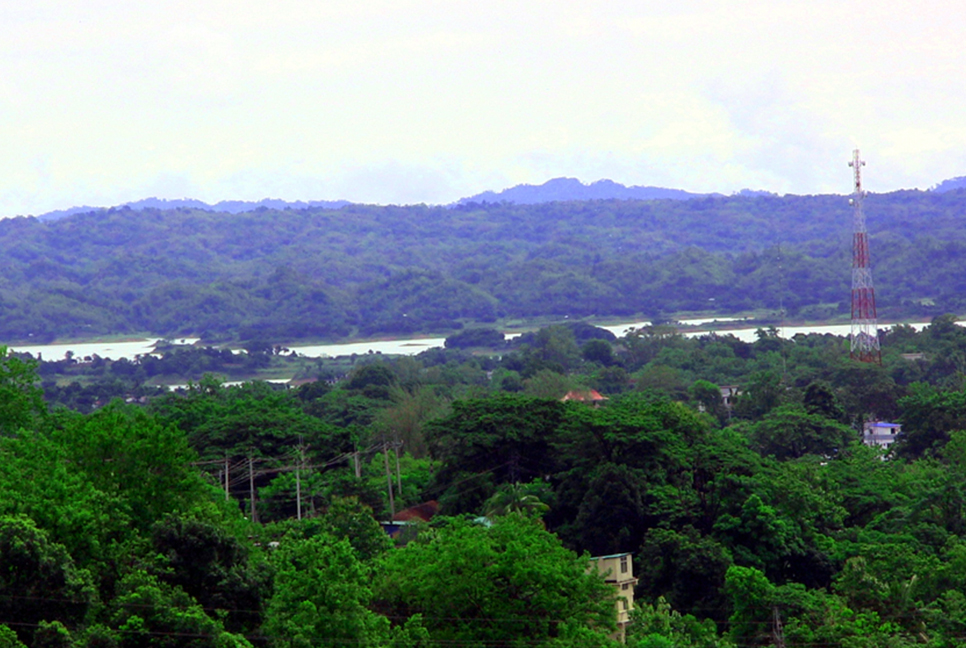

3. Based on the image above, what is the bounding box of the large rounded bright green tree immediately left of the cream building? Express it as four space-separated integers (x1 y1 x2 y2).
375 515 616 648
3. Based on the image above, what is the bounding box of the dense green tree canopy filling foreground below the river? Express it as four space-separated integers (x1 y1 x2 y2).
7 302 966 648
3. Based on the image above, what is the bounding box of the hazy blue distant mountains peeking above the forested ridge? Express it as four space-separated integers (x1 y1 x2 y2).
38 176 966 220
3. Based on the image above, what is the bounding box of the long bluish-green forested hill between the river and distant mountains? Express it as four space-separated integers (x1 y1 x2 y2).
0 190 966 341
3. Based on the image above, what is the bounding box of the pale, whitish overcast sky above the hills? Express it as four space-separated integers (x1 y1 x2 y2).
0 0 966 217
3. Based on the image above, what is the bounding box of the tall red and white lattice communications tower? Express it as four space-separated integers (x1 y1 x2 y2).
849 149 882 364
